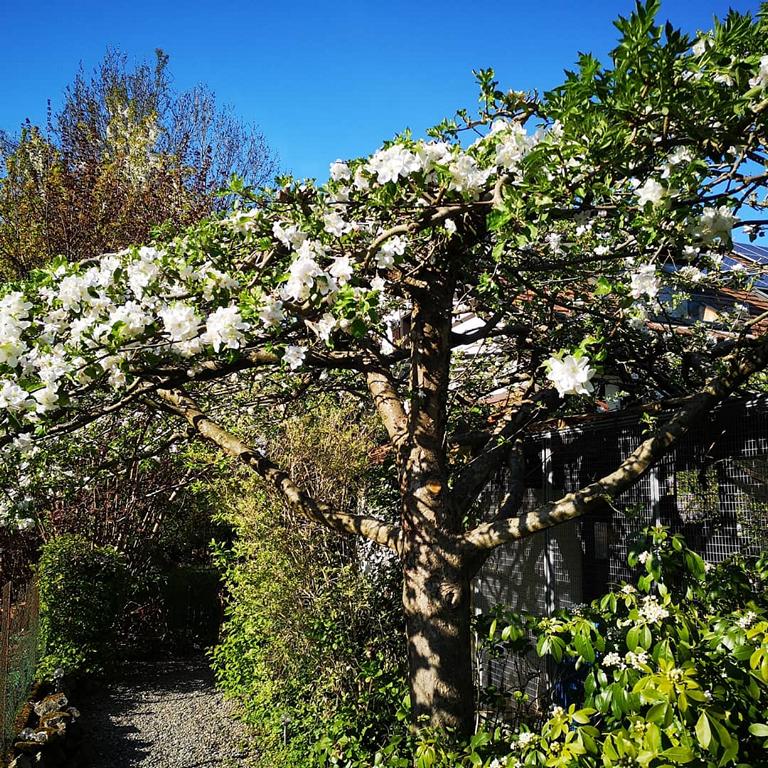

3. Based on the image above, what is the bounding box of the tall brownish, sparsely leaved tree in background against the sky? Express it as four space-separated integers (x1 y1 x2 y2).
0 50 275 277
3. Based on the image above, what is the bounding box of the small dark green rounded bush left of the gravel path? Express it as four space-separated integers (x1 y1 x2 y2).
37 535 127 677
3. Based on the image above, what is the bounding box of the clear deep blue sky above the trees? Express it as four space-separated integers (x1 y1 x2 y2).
0 0 759 179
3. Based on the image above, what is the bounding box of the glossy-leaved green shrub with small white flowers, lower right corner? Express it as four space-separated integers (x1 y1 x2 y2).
482 527 768 768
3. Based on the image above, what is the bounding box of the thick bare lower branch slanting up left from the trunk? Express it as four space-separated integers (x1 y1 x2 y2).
157 389 401 553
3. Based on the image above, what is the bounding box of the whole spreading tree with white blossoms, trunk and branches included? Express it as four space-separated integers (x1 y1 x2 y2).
0 0 768 731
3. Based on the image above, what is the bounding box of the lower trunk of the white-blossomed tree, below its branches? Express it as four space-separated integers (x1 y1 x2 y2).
403 542 475 736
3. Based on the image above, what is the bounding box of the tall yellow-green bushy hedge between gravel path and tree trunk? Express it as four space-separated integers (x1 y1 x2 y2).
207 401 406 768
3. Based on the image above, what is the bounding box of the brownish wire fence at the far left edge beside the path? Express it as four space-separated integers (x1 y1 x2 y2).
0 581 40 765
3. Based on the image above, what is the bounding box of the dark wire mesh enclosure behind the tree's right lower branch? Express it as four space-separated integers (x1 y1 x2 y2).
475 397 768 720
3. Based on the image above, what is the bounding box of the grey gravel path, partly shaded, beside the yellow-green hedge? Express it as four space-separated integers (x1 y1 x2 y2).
71 658 254 768
